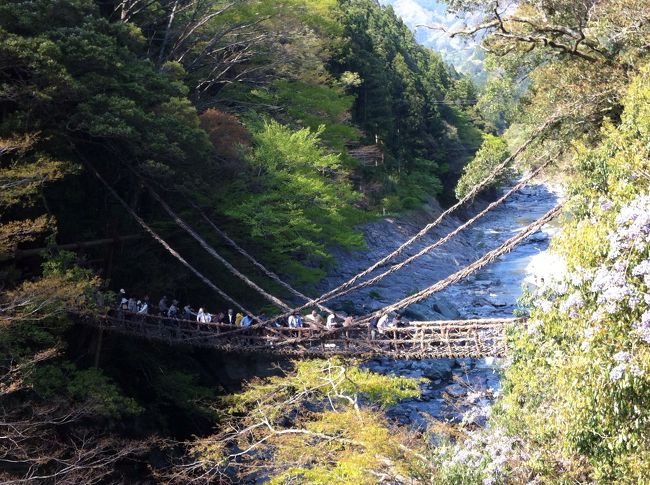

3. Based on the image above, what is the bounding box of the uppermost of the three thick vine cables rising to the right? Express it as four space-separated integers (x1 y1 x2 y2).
276 114 562 319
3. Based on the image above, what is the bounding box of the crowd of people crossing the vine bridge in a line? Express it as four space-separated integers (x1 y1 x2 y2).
111 289 404 340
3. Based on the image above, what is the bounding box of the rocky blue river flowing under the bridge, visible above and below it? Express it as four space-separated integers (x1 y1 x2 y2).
320 184 561 426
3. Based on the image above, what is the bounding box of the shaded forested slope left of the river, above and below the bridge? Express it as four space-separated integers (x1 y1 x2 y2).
0 0 482 483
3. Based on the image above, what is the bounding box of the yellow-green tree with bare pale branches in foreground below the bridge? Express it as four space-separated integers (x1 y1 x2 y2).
186 359 428 484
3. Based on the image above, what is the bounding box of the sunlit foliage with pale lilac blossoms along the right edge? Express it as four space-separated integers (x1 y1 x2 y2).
484 68 650 483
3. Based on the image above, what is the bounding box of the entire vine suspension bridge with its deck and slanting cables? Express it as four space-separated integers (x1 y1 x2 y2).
79 114 563 358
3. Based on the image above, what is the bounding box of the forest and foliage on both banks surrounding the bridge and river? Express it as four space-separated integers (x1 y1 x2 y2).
0 0 650 484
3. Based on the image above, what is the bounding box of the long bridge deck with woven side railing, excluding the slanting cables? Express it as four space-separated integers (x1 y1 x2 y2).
80 314 525 359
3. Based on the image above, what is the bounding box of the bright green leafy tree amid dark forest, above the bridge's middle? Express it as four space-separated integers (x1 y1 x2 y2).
222 121 363 279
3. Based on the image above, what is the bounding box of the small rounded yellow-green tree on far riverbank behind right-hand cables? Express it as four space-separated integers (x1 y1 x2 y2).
456 135 512 199
